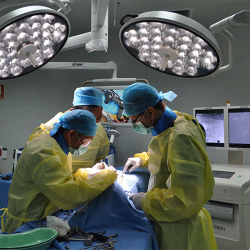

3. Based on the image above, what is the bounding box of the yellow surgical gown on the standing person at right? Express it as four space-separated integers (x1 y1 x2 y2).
135 111 217 250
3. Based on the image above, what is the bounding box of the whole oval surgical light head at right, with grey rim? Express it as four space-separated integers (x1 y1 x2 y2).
119 11 221 77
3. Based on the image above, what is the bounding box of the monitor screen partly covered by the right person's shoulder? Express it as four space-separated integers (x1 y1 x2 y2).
195 109 225 147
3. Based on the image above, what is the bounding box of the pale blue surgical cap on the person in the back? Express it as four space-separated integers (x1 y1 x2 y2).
73 87 102 106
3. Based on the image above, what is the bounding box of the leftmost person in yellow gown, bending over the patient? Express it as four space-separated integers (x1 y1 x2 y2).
2 110 117 233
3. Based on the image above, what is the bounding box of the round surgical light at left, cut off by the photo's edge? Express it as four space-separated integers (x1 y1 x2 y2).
0 6 70 80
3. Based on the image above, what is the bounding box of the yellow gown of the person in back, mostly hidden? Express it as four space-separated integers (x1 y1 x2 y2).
44 112 110 172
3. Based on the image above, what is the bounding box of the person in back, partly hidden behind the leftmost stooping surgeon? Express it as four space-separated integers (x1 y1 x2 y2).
41 87 110 171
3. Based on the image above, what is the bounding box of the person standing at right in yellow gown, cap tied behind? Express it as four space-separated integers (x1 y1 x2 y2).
123 83 217 250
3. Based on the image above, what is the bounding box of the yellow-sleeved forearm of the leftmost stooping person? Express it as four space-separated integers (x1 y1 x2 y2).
34 164 117 210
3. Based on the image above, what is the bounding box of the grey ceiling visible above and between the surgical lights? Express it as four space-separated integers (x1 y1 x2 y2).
0 0 250 36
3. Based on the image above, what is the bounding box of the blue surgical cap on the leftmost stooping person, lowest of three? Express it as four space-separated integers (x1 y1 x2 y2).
50 109 97 136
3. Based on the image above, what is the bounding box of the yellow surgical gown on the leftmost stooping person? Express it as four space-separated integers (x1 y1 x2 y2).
5 132 116 233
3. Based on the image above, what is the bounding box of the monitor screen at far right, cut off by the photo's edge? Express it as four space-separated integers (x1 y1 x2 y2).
228 108 250 148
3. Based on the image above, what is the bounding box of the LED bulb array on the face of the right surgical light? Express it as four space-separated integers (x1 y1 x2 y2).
122 22 217 76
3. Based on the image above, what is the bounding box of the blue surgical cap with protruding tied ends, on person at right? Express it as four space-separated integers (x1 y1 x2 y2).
123 82 177 116
